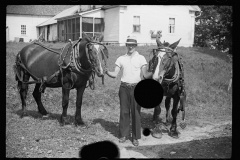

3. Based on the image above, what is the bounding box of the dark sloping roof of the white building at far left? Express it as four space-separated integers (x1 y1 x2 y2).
7 5 74 16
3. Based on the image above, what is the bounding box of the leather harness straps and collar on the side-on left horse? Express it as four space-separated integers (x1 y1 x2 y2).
13 38 108 92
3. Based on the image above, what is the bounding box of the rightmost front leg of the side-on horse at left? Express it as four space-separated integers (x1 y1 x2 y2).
75 85 86 126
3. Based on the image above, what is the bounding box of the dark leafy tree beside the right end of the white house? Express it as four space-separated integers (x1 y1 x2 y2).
194 5 232 54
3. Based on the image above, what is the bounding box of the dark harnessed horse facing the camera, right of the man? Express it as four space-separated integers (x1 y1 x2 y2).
149 39 186 138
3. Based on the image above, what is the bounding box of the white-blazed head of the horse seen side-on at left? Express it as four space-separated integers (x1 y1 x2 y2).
83 33 108 77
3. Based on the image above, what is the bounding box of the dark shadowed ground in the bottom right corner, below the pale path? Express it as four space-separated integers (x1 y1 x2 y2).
126 137 232 159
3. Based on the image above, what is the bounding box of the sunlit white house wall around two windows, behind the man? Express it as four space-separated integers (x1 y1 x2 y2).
118 5 197 47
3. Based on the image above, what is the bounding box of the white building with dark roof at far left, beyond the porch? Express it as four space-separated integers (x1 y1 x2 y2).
6 5 74 42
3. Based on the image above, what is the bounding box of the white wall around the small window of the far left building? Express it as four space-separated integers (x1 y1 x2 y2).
6 14 51 42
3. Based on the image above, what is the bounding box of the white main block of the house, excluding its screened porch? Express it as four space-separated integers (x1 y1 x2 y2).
104 5 200 47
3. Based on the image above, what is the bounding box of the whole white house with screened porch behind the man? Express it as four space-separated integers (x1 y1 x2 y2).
56 5 200 47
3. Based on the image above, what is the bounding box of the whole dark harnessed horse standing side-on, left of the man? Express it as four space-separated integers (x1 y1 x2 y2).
14 33 108 125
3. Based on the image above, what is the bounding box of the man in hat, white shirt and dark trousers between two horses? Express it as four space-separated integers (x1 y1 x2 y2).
105 36 152 146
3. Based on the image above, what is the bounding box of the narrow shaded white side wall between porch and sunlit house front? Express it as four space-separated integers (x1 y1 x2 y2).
104 7 119 43
